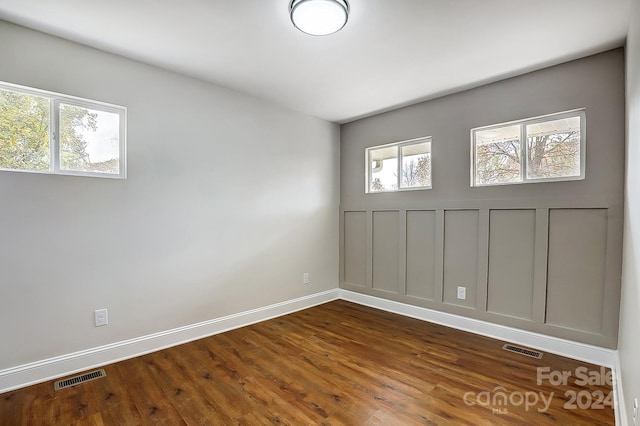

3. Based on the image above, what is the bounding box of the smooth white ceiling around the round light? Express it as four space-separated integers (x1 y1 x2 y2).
0 0 630 123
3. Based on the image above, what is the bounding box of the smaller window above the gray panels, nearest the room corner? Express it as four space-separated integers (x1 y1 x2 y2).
365 137 431 193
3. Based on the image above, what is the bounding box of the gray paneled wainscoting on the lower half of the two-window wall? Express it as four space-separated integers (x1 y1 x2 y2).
340 207 621 348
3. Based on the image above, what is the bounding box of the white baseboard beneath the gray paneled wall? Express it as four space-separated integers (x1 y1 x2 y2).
340 289 616 368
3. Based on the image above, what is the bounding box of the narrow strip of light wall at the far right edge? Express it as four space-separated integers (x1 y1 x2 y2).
618 0 640 424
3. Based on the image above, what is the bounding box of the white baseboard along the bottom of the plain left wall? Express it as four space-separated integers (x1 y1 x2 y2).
0 289 340 393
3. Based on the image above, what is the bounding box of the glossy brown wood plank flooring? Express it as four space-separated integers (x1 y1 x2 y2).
0 301 614 426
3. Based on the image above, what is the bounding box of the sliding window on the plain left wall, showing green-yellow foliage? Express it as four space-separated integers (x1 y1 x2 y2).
0 82 126 178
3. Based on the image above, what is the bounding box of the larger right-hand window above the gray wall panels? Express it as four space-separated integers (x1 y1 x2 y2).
471 110 585 186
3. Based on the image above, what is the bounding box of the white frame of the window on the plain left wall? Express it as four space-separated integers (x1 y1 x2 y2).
0 81 127 179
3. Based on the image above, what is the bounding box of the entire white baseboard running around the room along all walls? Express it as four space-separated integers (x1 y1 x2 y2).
0 289 625 398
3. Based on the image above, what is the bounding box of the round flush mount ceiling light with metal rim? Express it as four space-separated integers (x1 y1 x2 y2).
289 0 349 35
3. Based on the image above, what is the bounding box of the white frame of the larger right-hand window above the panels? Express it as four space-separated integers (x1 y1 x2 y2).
470 108 587 187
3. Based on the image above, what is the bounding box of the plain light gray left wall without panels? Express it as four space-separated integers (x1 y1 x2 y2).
0 21 339 369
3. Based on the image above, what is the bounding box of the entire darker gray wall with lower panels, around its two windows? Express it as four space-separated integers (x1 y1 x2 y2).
340 49 625 348
